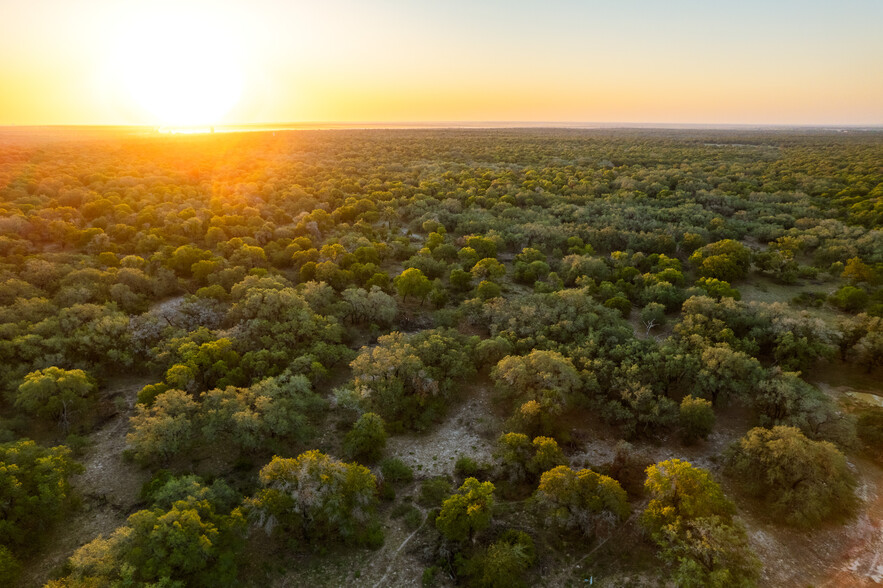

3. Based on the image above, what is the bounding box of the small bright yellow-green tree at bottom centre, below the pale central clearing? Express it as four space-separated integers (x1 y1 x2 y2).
435 478 494 541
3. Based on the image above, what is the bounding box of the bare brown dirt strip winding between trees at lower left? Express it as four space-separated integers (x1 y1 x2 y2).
19 377 153 587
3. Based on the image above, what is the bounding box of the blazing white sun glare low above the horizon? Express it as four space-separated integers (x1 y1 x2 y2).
117 11 243 127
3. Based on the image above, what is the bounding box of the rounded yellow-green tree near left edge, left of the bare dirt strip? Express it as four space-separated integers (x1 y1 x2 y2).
15 367 97 432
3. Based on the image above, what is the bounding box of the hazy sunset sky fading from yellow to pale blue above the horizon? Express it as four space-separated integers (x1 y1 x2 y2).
0 0 883 125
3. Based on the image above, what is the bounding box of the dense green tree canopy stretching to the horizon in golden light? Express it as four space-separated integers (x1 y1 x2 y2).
0 129 883 588
